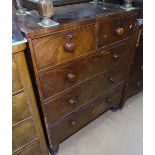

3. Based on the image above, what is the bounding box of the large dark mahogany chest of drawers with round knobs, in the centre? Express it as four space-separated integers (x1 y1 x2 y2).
18 3 138 154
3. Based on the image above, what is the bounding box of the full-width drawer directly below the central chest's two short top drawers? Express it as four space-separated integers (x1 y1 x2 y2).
40 42 130 99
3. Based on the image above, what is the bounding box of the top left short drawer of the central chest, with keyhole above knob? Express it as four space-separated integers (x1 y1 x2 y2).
33 25 95 70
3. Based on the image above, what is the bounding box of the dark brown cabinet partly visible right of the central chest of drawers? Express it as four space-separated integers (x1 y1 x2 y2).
120 19 143 108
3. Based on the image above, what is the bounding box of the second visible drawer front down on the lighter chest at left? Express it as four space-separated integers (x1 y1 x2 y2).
12 93 30 124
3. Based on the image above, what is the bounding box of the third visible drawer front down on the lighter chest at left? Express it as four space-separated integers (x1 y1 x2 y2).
12 119 37 152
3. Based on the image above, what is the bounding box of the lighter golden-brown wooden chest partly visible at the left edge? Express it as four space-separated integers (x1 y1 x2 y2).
12 44 48 155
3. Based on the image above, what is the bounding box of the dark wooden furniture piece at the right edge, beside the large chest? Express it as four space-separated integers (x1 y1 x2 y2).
127 20 143 98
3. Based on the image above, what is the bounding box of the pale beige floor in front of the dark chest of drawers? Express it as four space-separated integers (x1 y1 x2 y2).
57 93 143 155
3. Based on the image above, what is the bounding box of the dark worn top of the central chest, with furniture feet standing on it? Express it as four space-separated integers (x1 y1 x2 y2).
18 3 138 38
